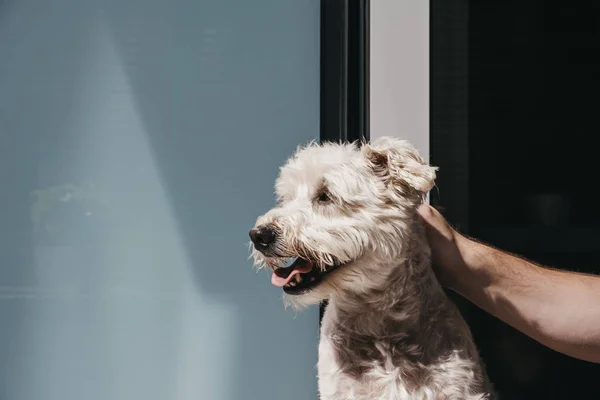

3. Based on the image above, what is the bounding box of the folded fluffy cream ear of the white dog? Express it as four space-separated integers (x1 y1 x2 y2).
361 137 437 194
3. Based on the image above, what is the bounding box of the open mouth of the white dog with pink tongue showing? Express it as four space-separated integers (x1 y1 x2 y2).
271 257 338 295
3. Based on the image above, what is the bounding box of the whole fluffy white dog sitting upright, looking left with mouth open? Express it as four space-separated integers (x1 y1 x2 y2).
250 137 492 400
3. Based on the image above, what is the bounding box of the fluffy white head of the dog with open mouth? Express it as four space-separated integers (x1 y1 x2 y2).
250 138 436 306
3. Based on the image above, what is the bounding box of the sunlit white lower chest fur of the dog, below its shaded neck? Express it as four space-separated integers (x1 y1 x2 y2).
318 304 488 400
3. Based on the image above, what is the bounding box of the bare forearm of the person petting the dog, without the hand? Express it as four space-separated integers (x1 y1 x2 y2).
455 239 600 362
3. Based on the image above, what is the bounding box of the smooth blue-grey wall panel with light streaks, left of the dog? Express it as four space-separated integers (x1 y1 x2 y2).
0 0 319 400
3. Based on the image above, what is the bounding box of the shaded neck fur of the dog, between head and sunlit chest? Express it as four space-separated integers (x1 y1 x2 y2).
321 217 478 375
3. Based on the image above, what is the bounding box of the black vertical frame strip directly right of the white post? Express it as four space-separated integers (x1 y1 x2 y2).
429 0 469 233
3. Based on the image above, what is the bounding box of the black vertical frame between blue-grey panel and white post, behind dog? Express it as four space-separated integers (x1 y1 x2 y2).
319 0 370 321
